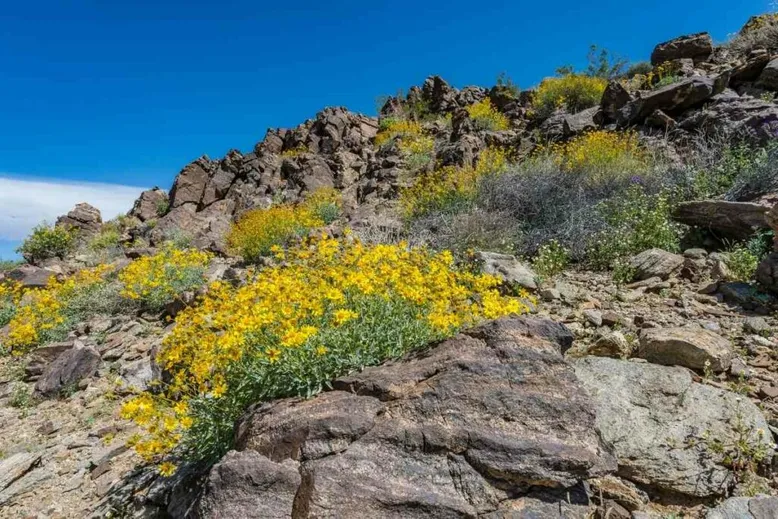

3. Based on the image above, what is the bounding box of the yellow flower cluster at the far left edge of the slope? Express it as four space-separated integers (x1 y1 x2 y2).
4 265 111 354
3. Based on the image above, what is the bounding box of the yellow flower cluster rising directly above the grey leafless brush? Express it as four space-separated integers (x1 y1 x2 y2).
536 130 651 181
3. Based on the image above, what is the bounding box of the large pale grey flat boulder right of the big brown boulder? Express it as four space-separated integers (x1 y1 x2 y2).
573 357 772 498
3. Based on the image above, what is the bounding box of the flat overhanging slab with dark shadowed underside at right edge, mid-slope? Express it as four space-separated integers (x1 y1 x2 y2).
673 200 770 240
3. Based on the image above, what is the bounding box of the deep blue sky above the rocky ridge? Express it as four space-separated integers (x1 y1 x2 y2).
0 0 770 257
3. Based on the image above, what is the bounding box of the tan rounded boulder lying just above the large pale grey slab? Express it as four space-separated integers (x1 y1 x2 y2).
638 326 734 373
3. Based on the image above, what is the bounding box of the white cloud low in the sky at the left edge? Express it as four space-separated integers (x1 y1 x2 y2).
0 176 143 241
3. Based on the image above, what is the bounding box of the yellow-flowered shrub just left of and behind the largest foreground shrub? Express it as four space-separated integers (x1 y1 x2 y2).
119 245 211 311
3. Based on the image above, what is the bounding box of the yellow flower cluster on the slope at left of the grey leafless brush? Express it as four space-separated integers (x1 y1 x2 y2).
400 148 508 218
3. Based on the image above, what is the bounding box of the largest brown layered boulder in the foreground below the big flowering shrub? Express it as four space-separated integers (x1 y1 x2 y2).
200 319 616 519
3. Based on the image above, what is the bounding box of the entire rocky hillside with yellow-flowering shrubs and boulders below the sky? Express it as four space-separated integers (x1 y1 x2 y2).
0 15 778 519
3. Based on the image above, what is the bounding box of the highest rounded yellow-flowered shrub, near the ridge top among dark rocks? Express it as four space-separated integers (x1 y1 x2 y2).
532 74 608 117
